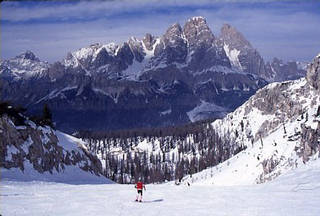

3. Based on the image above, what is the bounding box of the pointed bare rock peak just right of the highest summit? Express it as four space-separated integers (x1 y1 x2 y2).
220 24 252 48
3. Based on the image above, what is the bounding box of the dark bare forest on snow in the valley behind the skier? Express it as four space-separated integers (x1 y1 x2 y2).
77 122 244 183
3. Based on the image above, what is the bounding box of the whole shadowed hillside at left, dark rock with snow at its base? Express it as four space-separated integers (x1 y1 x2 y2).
0 104 111 184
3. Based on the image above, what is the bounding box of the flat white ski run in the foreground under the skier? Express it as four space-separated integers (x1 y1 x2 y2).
0 160 320 216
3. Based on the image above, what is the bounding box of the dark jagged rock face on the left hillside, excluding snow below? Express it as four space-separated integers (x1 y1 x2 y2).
0 115 103 175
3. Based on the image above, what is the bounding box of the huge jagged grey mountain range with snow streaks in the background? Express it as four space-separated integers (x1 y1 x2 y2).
0 17 308 132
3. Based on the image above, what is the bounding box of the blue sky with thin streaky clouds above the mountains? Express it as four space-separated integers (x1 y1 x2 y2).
0 0 320 62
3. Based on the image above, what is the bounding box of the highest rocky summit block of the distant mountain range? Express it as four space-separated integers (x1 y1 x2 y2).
183 17 215 46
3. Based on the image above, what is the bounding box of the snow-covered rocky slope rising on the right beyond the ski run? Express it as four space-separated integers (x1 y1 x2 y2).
184 74 320 185
